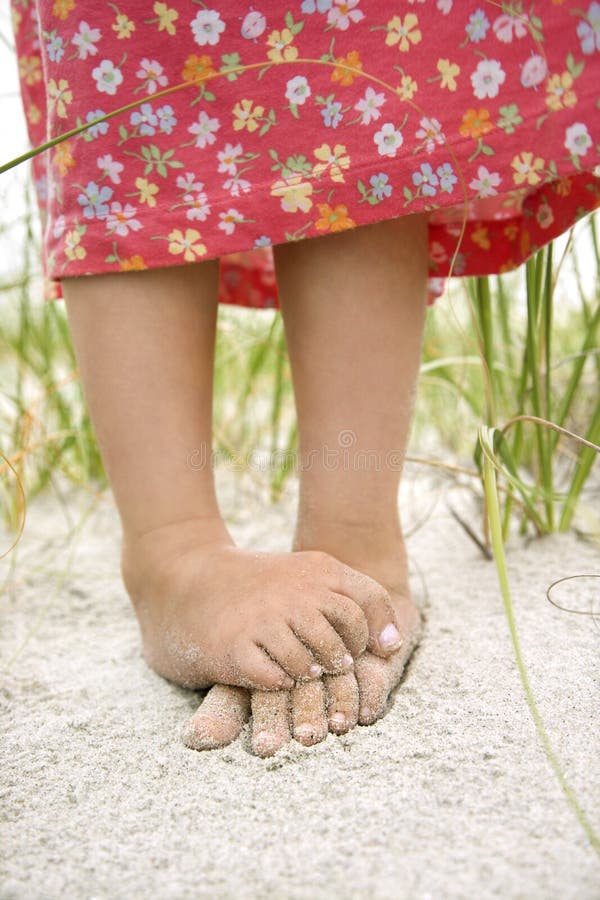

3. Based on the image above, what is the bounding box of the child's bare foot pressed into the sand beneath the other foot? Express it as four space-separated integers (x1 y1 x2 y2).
184 525 422 756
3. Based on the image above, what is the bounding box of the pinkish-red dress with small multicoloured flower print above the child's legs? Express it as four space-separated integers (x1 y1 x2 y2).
12 0 600 307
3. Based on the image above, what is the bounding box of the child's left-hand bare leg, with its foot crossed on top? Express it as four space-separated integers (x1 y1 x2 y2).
64 262 393 688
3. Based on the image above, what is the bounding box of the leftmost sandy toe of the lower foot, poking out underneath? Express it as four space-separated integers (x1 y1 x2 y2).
182 684 250 750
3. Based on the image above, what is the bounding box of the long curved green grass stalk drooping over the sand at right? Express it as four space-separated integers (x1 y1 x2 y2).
479 425 600 856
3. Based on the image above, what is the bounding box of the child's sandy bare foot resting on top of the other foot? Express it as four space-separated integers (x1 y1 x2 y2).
122 519 398 690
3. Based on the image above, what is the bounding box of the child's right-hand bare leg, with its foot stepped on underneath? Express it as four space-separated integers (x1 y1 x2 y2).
186 216 427 755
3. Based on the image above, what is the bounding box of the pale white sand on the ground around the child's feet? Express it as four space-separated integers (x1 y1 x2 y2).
0 472 600 900
